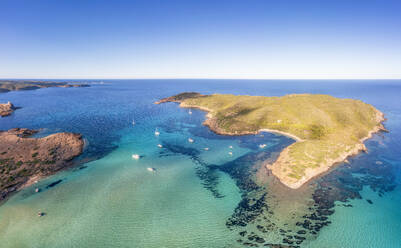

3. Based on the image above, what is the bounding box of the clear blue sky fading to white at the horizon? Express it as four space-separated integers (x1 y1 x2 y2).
0 0 401 79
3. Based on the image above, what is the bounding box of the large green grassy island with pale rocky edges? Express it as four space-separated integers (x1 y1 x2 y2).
156 92 386 189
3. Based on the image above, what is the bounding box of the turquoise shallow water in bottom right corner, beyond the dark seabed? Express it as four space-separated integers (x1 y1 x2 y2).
307 187 401 248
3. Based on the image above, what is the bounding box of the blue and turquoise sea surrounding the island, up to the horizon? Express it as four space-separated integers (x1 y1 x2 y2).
0 80 401 248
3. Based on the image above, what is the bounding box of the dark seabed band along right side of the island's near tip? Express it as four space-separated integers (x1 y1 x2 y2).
294 143 396 246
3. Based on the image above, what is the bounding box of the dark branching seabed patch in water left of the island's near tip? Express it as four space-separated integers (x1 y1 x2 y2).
159 133 302 247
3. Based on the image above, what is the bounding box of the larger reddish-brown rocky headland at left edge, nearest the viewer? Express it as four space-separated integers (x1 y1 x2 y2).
0 128 84 202
